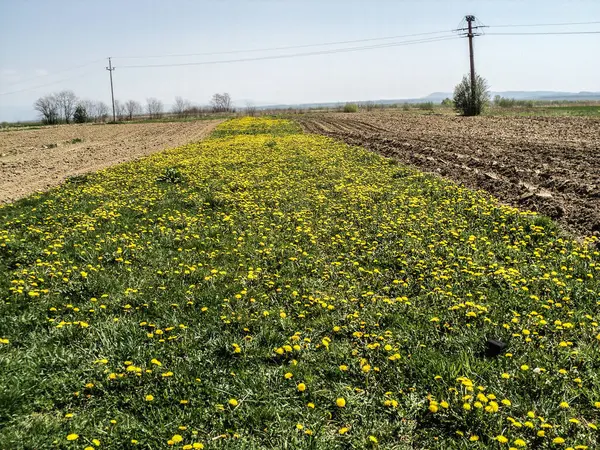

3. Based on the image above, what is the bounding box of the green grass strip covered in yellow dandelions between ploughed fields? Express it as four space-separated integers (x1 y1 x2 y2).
0 118 600 450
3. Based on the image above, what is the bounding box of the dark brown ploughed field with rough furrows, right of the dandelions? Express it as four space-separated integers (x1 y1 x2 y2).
299 112 600 236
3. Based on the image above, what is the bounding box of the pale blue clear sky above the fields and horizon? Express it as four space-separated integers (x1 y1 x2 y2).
0 0 600 122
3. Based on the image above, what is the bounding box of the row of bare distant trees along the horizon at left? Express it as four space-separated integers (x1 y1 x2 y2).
33 90 235 125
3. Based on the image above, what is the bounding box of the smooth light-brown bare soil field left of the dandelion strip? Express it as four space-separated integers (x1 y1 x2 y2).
0 120 221 203
